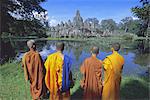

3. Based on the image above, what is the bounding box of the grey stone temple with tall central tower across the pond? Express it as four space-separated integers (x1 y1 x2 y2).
47 10 109 37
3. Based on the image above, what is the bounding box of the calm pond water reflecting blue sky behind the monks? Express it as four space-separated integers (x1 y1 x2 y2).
1 40 150 75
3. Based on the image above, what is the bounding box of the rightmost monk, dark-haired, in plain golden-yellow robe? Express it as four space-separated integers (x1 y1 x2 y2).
102 43 124 100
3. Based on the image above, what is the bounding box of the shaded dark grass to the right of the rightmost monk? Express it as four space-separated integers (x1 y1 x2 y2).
121 76 150 100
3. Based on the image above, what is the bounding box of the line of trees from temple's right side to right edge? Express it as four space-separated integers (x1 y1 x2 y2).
92 0 150 37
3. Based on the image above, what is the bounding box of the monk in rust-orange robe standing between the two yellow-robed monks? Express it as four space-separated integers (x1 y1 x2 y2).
80 46 102 100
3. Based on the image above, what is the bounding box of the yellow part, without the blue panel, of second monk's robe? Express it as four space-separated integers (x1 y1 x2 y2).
45 52 63 100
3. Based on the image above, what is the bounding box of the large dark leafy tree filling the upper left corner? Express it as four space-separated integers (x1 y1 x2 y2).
0 0 46 35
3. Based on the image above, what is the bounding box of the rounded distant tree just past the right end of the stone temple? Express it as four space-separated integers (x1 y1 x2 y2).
101 19 116 32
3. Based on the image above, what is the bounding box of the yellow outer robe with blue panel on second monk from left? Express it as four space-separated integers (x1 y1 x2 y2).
45 52 71 95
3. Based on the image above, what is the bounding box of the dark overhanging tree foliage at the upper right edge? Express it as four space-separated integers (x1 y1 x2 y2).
131 0 150 36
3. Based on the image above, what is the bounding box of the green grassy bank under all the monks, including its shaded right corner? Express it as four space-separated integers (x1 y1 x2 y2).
0 62 150 100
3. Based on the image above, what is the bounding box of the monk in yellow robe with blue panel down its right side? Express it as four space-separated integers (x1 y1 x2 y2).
45 42 72 100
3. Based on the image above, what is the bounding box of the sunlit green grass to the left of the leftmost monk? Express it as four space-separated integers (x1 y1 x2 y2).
0 63 31 100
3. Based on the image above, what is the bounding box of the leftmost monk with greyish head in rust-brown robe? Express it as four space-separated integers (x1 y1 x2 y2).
22 40 46 100
